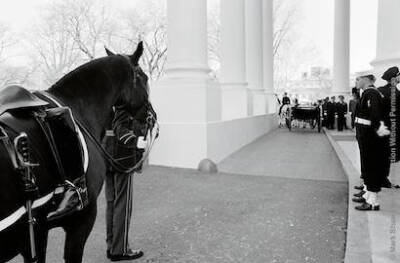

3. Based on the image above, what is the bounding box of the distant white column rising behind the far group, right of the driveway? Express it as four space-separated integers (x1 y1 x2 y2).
332 0 350 95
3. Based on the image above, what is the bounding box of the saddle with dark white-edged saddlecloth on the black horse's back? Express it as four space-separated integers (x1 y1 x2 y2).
0 86 85 193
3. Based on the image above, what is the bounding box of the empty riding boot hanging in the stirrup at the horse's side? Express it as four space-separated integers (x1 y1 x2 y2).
47 176 89 221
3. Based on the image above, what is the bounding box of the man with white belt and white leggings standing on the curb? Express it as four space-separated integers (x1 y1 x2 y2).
353 75 390 211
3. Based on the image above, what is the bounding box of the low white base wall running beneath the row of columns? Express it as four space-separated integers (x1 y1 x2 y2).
149 114 277 168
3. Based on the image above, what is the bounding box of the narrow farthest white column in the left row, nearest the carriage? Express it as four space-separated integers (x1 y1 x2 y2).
263 0 277 113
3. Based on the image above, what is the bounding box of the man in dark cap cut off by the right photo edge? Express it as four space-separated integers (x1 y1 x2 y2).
378 67 400 188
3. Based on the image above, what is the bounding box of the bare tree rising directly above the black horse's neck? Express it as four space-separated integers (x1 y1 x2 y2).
28 0 120 84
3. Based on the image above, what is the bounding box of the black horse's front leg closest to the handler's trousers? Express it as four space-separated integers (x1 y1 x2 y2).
64 205 97 263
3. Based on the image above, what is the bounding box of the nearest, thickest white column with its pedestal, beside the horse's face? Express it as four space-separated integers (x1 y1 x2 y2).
150 0 221 168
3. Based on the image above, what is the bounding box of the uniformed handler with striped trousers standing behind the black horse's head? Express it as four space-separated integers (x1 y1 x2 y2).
106 106 147 261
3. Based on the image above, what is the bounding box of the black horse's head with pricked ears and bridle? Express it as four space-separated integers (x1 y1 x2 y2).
105 42 150 121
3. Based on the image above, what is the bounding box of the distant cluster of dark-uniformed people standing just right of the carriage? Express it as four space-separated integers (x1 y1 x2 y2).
320 95 348 131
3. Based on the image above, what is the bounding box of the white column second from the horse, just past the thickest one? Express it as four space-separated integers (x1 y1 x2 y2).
220 0 247 120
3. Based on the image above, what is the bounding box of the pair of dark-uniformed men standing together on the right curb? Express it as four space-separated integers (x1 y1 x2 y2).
353 67 400 211
